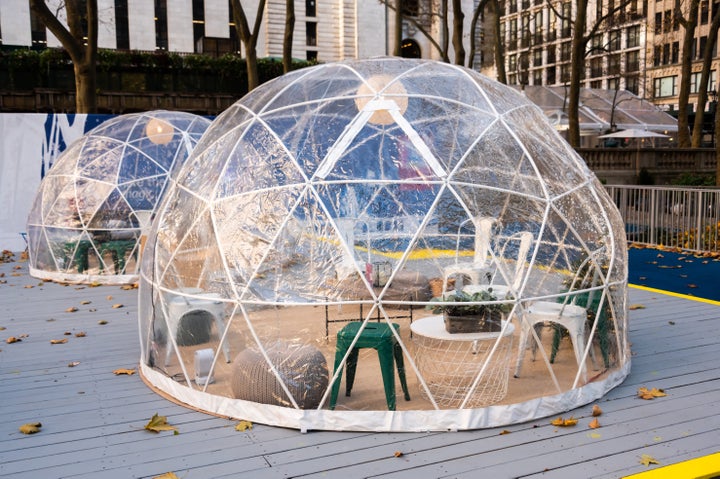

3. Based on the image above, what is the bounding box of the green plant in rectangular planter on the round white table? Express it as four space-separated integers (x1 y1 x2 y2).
428 288 512 334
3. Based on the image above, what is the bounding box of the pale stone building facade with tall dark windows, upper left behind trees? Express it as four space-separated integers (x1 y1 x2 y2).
0 0 474 62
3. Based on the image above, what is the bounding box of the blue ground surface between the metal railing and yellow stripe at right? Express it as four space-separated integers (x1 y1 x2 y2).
628 248 720 301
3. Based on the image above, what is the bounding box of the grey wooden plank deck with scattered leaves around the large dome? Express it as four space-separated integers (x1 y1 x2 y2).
0 256 720 479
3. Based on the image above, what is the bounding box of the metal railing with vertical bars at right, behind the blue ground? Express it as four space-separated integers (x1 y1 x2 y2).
605 185 720 252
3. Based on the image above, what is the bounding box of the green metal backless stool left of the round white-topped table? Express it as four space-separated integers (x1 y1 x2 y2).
330 321 410 411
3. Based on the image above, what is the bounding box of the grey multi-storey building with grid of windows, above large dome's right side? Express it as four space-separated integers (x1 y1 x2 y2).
486 0 646 97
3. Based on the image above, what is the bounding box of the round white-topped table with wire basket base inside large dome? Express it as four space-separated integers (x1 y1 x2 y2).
410 315 515 408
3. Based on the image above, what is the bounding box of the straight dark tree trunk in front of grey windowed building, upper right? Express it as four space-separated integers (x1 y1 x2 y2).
567 1 587 148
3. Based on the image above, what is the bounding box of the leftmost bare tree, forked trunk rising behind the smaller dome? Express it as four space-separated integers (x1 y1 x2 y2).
30 0 98 113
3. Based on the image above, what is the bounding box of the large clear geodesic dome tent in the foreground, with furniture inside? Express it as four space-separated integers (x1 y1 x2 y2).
139 58 630 430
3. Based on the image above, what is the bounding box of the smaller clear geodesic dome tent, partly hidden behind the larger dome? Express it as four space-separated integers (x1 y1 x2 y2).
27 111 210 283
